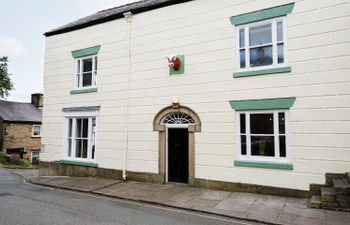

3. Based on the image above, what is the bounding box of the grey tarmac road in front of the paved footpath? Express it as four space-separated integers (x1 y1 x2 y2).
0 168 262 225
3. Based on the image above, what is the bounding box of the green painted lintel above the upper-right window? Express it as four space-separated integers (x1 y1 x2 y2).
230 2 294 26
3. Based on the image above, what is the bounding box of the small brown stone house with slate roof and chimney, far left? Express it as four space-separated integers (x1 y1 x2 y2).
0 94 43 161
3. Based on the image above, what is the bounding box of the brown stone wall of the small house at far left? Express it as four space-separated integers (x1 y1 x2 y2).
3 123 41 160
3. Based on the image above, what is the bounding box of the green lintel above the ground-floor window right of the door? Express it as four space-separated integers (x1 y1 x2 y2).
230 97 296 111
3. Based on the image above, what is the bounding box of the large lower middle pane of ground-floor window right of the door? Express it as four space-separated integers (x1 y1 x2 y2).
251 136 275 156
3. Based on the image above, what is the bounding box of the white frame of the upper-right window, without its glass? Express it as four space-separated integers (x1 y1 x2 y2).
236 16 288 72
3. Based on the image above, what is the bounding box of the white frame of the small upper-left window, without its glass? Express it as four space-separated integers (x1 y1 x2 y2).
74 55 98 90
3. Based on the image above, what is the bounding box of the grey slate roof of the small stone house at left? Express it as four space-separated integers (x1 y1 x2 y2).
0 100 42 123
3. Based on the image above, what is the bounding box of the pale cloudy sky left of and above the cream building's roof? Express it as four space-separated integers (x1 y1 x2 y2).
0 0 137 102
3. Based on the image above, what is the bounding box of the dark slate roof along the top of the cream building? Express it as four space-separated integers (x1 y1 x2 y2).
44 0 193 36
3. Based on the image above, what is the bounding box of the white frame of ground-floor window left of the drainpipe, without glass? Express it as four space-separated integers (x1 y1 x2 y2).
61 112 97 163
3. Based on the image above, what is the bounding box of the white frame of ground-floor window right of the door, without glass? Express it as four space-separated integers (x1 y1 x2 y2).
236 110 291 163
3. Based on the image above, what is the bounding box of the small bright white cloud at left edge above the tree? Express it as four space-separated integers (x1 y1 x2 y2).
0 36 27 58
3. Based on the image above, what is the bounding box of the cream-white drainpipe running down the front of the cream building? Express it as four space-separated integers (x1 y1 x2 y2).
123 12 133 181
